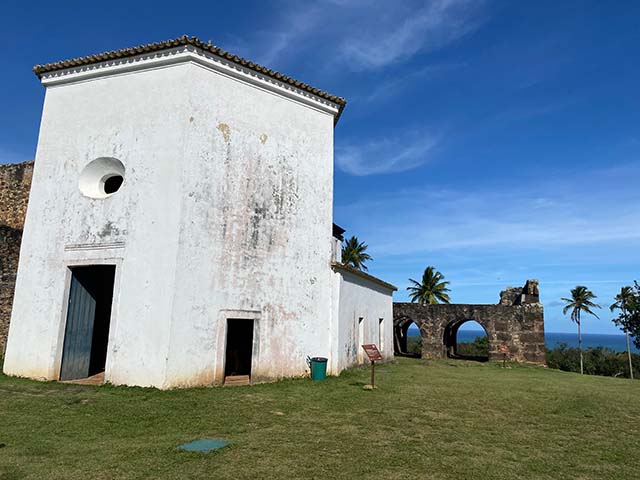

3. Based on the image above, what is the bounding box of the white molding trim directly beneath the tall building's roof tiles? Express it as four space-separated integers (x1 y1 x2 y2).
41 45 340 117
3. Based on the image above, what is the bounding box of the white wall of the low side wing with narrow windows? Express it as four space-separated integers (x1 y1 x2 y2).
333 268 393 371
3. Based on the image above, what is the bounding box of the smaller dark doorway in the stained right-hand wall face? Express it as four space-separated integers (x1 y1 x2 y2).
224 318 253 385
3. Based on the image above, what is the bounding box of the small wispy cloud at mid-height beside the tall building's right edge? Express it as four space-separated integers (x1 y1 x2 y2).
336 133 438 176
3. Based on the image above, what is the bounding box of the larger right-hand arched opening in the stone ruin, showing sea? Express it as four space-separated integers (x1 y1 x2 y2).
444 319 489 362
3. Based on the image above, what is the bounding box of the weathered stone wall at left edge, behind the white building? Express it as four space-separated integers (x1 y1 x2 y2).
0 162 33 356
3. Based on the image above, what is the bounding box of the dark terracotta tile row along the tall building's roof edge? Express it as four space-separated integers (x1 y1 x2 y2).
33 35 347 117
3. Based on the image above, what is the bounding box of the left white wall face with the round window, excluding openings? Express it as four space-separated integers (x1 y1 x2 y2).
4 65 189 386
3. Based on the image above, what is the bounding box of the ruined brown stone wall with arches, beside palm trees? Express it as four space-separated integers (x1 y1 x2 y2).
393 281 545 363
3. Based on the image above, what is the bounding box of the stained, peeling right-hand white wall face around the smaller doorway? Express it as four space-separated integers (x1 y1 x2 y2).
162 65 333 386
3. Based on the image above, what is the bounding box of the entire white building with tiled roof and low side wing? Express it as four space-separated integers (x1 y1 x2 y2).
4 37 395 388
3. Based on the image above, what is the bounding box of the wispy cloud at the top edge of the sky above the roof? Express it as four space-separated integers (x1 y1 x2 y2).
245 0 484 70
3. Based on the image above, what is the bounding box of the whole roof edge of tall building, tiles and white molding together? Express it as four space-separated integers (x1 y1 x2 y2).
33 35 347 122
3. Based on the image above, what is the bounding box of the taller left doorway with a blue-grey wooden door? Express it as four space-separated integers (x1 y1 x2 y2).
60 265 116 383
